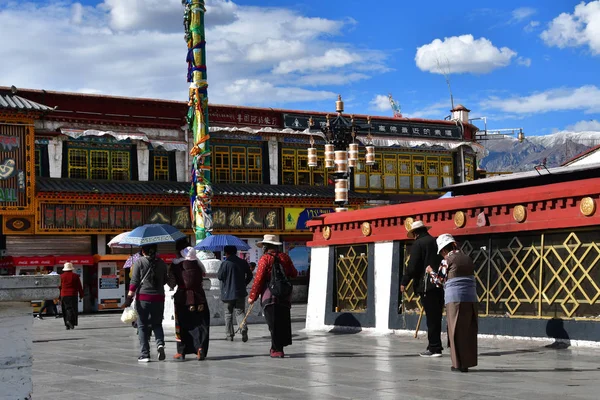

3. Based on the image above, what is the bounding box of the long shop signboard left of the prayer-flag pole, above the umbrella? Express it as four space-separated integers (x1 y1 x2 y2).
36 203 191 233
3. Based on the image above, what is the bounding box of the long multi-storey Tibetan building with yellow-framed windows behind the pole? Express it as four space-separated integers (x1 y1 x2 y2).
0 87 482 310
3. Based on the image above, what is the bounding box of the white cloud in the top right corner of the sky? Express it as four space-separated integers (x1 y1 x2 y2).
540 0 600 54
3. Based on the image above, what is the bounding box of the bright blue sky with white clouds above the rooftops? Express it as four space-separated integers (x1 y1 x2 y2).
0 0 600 136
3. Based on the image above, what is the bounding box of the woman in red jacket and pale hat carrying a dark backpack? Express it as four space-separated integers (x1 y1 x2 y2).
248 235 298 358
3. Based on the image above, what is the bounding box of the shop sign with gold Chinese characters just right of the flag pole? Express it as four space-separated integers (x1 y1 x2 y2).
213 207 281 230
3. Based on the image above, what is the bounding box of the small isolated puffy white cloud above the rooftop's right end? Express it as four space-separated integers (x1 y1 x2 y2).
415 35 517 74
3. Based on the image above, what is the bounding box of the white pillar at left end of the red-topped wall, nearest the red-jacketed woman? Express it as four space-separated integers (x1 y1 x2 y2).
306 247 329 330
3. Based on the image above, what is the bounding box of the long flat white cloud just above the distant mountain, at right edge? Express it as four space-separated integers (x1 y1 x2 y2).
481 85 600 114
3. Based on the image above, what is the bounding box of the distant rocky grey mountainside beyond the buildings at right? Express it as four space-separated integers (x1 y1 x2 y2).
480 131 600 172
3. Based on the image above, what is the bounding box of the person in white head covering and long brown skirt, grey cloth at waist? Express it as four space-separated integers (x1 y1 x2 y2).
426 233 478 372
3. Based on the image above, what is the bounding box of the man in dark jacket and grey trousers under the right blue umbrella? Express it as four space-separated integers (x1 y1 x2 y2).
218 246 252 342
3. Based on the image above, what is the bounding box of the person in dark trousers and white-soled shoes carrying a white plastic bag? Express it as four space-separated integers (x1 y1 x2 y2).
124 244 167 362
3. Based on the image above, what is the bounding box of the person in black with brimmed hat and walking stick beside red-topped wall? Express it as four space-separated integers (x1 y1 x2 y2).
400 221 444 357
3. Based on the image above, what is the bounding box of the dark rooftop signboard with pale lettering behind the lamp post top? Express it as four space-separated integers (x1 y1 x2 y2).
283 114 462 140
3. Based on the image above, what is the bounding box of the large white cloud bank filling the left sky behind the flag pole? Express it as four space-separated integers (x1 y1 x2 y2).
0 0 387 106
